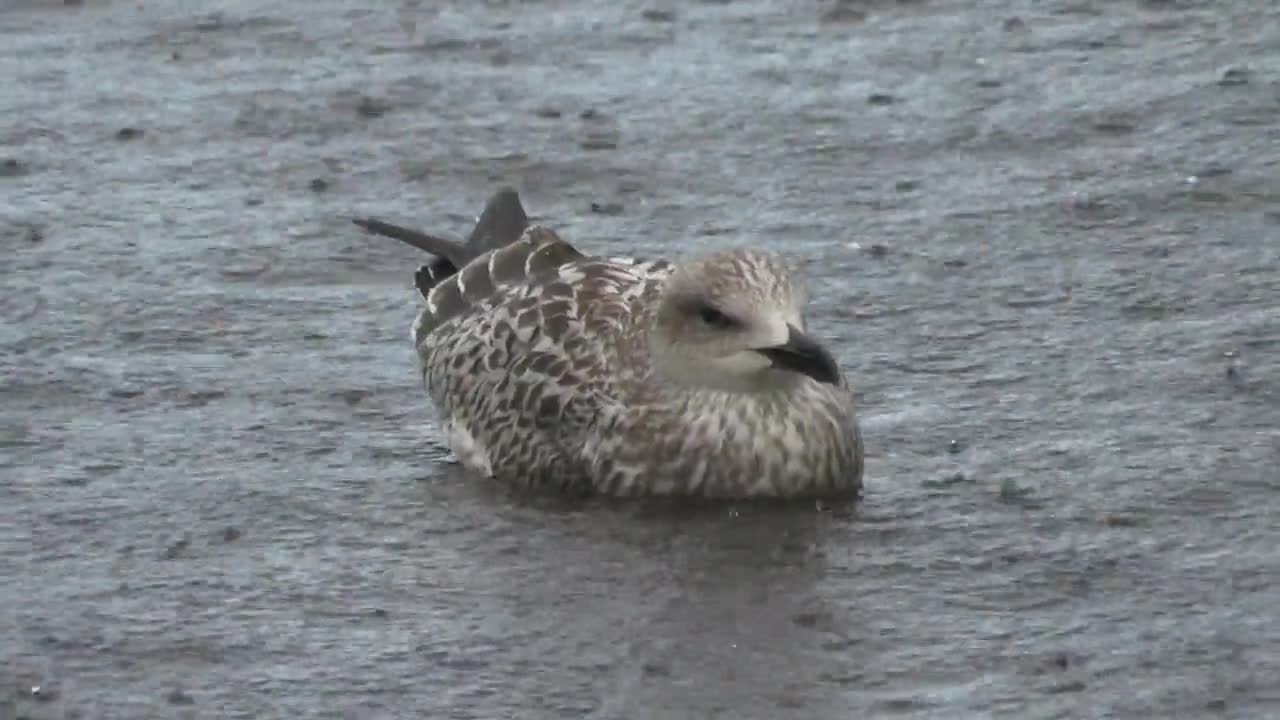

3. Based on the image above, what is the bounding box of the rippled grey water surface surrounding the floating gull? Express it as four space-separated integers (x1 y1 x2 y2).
0 0 1280 720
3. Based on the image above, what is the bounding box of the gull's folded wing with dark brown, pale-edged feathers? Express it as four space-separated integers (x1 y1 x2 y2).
413 225 666 488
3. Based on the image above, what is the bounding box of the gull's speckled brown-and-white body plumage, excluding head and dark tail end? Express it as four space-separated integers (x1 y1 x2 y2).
413 225 863 497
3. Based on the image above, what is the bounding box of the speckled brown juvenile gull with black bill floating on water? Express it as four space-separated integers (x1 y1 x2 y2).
355 188 863 498
